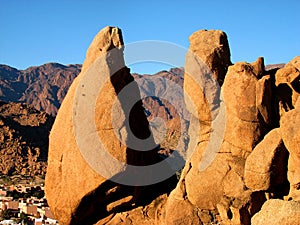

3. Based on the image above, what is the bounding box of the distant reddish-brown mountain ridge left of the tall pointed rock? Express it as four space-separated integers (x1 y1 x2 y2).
0 63 81 116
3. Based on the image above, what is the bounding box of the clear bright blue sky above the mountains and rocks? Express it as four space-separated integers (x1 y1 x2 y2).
0 0 300 73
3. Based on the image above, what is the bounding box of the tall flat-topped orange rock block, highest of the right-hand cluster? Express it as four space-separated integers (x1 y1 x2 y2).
184 30 231 122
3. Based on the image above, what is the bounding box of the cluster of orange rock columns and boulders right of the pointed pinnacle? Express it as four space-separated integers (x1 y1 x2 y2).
166 31 299 224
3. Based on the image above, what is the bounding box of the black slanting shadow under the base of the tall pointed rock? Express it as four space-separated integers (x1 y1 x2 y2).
70 171 177 225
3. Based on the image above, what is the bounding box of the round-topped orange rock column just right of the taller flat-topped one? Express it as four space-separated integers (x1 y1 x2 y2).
222 58 272 158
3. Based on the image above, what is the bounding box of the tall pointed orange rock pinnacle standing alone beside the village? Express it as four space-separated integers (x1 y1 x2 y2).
45 27 166 225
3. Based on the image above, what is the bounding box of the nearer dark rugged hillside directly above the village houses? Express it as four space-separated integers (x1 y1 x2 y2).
0 102 54 176
